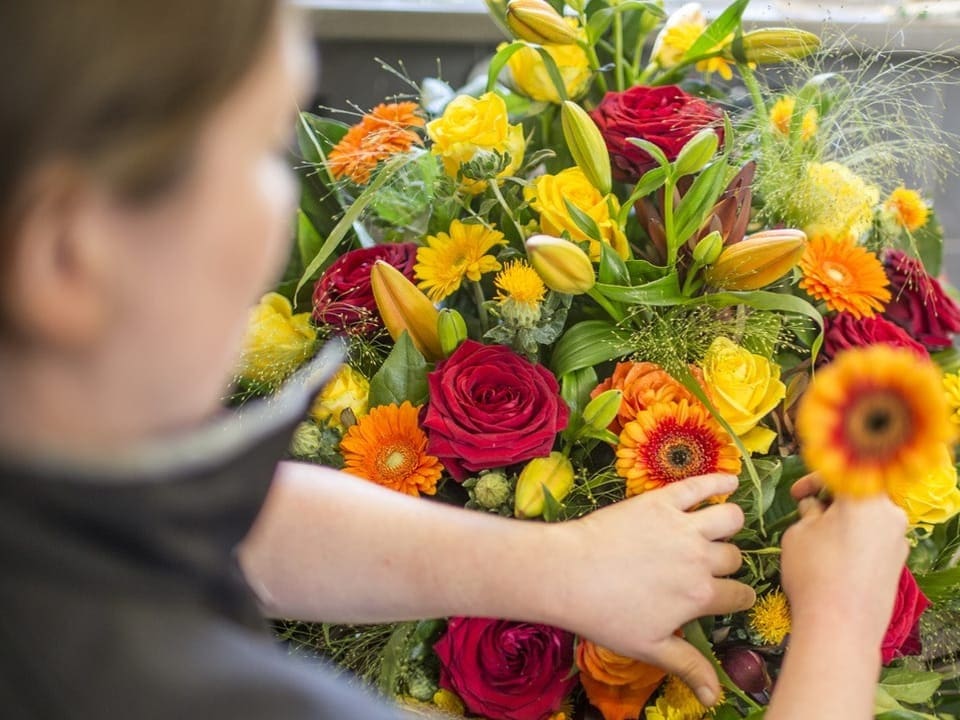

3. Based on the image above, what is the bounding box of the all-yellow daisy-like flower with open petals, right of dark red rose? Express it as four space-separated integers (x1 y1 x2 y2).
413 220 507 302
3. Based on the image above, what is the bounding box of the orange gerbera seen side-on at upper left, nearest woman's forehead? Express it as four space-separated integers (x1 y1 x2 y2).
327 102 424 185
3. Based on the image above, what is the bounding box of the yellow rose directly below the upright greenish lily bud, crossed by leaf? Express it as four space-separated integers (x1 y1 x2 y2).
523 167 630 262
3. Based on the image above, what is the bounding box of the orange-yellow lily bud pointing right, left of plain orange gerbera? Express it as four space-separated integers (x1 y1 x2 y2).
705 229 807 290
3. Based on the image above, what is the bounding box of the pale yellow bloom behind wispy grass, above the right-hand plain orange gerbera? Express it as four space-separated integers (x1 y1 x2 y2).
788 162 880 238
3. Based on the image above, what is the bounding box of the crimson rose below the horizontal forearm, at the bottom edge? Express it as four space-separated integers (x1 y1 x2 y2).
433 617 577 720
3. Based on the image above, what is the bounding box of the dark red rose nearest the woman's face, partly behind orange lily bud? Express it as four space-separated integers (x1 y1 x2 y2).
313 243 417 335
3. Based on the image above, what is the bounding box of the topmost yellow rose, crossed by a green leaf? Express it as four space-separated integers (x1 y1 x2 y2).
498 18 590 104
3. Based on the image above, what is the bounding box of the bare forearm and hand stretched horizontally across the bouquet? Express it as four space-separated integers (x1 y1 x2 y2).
240 463 754 701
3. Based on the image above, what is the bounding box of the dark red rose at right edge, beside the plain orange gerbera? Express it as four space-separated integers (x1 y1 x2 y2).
883 250 960 350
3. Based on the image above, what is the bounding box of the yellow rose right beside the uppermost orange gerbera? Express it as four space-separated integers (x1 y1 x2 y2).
427 92 526 194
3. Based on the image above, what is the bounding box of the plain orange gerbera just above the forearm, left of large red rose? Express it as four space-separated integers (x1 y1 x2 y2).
340 402 443 496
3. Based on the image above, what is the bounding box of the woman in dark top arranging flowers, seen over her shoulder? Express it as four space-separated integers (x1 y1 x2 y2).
0 0 908 718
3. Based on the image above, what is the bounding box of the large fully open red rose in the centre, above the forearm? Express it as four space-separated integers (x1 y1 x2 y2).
423 340 570 480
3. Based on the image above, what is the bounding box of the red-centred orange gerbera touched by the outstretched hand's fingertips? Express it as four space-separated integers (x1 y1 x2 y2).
616 400 740 496
